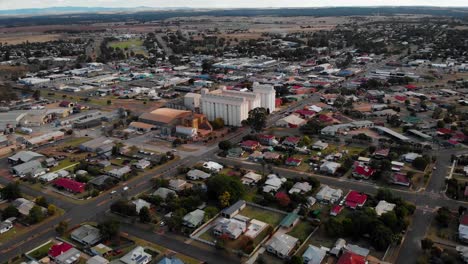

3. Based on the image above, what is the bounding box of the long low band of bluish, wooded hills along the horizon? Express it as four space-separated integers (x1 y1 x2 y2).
0 6 468 27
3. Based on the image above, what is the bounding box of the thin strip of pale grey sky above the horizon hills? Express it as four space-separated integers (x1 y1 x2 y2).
0 0 468 10
